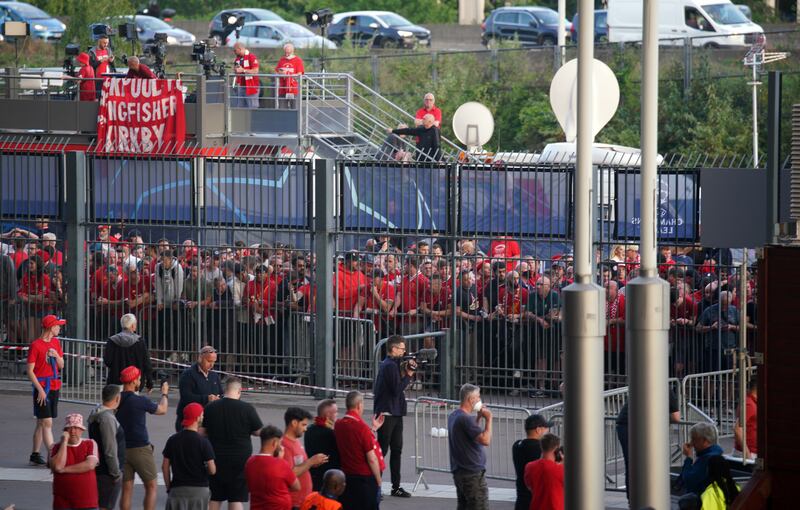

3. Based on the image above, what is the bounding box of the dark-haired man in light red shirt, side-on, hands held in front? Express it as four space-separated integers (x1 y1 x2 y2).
281 407 328 508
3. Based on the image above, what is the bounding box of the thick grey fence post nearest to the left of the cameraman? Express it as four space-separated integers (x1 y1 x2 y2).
313 159 336 398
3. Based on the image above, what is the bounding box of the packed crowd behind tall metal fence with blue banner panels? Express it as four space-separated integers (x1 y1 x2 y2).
0 145 757 407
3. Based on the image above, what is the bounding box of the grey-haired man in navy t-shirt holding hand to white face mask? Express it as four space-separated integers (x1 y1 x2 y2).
447 384 492 510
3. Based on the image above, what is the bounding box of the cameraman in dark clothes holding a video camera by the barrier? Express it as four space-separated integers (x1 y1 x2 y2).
375 335 417 498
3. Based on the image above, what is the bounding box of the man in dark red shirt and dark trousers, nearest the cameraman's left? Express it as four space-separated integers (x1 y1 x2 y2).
333 391 385 510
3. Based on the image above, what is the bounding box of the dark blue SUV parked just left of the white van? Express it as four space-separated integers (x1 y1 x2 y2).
481 7 571 47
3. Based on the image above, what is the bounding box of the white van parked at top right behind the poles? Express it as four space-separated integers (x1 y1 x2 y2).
608 0 764 48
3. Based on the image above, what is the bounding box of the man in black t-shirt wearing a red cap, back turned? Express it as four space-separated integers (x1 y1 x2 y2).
161 402 217 508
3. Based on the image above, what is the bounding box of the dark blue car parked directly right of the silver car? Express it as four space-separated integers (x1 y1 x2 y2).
328 11 431 48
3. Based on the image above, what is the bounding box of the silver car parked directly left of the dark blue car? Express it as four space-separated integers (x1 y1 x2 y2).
223 21 337 49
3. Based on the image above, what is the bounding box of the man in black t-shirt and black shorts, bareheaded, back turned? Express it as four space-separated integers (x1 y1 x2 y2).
203 377 264 508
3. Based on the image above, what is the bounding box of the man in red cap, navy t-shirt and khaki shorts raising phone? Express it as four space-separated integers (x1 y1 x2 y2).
117 366 169 510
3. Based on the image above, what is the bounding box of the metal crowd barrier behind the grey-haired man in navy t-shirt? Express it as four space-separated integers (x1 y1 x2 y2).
413 397 530 491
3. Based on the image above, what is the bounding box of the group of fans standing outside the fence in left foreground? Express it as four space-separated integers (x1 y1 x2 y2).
27 315 394 510
